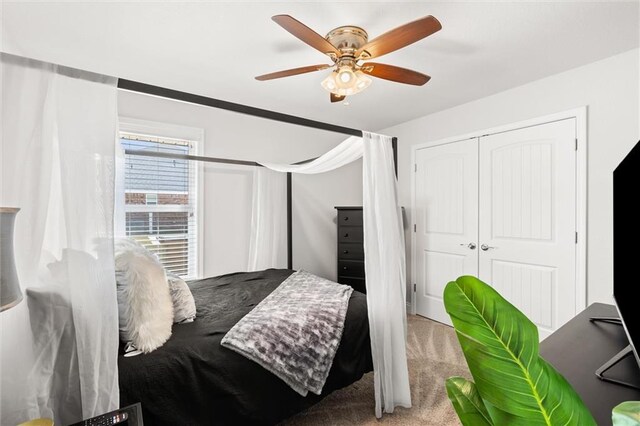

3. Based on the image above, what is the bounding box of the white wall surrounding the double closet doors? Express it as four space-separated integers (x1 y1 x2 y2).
382 49 640 303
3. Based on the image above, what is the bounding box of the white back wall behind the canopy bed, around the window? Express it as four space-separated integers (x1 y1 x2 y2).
118 91 362 279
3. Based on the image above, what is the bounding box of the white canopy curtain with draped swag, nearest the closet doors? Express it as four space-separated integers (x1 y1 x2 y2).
252 132 411 417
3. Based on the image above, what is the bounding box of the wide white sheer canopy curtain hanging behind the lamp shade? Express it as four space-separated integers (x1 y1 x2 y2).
0 53 119 425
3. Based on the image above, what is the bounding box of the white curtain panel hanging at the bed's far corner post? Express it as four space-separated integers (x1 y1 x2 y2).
247 167 287 271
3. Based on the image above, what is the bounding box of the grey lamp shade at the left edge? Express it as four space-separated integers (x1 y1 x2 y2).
0 207 22 312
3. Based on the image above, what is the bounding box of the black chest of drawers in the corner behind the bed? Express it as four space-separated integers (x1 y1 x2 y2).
336 207 367 293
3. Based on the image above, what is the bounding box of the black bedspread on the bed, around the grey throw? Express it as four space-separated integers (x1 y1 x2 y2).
118 269 373 425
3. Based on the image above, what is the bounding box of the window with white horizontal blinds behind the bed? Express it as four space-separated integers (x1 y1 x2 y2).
120 132 198 279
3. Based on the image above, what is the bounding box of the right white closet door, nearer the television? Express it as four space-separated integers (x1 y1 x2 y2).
478 119 576 338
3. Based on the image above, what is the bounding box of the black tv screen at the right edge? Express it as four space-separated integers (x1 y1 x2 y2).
613 142 640 365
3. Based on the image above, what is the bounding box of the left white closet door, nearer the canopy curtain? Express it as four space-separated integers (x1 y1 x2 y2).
414 138 478 324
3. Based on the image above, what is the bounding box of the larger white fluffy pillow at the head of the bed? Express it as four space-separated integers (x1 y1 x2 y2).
115 240 173 353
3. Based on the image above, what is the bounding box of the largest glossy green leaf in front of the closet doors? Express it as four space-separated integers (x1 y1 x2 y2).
444 276 596 426
